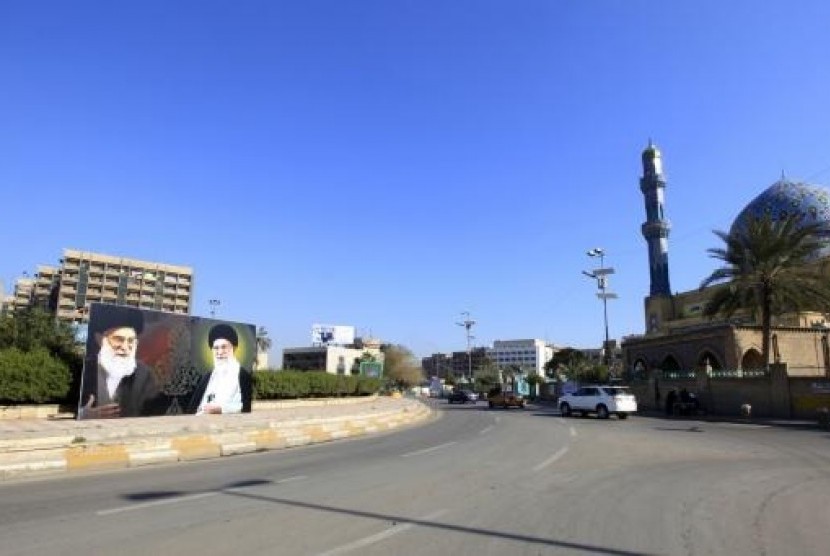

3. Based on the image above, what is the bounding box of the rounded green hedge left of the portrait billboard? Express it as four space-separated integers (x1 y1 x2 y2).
0 348 72 403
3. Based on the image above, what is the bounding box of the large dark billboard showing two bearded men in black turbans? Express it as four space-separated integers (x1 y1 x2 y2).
78 303 256 418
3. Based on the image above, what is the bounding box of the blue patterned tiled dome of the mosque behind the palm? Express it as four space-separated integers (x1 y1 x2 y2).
730 178 830 236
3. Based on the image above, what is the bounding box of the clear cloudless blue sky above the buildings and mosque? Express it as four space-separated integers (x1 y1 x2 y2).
0 0 830 359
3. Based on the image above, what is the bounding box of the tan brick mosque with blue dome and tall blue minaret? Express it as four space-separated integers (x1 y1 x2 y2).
621 142 830 417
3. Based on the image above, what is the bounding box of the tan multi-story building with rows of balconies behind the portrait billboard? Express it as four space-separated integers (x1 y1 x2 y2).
2 249 193 323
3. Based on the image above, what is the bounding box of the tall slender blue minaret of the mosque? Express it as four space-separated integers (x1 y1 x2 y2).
640 139 671 296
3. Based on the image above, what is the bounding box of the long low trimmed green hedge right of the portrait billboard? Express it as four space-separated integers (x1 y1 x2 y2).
254 371 381 400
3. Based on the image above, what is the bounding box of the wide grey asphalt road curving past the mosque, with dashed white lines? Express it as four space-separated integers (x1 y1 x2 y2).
0 402 830 556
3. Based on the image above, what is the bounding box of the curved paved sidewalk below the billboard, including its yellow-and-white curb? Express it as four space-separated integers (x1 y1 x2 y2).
0 396 434 481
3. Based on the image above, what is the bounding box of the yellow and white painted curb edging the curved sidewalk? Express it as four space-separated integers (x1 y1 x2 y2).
0 402 435 481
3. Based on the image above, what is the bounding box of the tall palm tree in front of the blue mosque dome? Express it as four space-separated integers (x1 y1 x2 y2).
700 215 830 366
